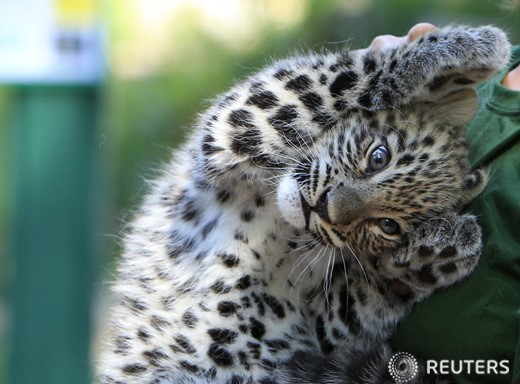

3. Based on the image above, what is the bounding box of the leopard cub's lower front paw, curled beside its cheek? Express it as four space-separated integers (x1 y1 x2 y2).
385 215 482 301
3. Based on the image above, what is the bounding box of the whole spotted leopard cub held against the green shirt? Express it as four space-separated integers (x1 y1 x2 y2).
98 27 509 384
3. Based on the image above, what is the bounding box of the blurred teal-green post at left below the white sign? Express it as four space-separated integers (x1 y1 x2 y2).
8 86 97 384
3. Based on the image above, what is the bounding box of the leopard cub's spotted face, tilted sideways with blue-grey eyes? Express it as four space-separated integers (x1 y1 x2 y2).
277 109 485 254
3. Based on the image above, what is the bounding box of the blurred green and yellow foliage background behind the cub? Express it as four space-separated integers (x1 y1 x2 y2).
0 0 520 384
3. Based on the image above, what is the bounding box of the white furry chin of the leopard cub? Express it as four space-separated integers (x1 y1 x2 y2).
276 176 307 229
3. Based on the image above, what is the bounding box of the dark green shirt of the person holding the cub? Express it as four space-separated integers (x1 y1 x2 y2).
393 46 520 384
